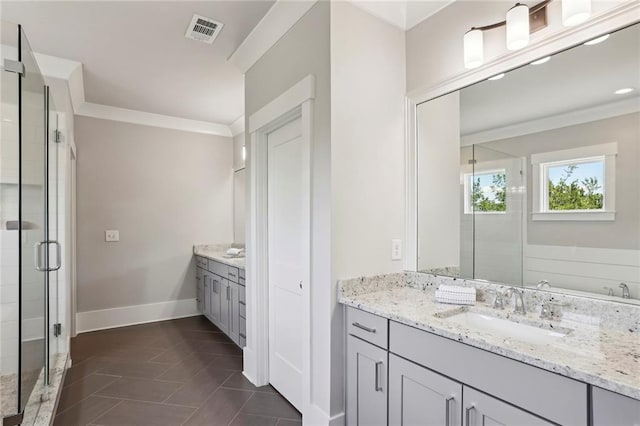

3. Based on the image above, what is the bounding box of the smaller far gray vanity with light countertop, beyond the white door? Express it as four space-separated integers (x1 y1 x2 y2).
194 246 247 348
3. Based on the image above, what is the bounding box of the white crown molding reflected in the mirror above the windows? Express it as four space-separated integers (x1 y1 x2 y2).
460 96 640 146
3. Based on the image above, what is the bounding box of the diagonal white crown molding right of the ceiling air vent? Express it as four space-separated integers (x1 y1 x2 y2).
229 0 317 73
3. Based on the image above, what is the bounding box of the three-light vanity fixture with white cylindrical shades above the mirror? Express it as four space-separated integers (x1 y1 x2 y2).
464 0 592 69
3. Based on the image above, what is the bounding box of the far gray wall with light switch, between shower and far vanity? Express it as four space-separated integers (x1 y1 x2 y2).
75 117 233 312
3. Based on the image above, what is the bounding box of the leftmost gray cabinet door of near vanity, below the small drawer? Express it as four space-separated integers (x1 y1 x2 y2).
347 336 388 426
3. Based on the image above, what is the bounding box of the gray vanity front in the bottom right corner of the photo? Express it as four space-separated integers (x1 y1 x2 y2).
591 386 640 426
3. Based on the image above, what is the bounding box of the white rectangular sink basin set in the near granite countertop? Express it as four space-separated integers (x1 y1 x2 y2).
446 311 570 345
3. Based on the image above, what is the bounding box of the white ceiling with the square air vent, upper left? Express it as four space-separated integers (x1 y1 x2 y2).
0 0 273 125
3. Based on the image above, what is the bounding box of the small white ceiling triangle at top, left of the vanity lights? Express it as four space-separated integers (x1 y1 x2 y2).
349 0 455 31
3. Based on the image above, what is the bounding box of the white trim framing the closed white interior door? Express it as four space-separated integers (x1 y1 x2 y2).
243 75 315 412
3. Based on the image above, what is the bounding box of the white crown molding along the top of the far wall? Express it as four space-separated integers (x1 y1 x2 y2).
75 102 231 137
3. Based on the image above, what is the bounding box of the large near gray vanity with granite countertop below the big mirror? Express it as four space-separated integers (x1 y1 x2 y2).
339 273 640 426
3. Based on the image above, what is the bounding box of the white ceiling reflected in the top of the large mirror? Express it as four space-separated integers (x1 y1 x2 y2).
460 24 640 136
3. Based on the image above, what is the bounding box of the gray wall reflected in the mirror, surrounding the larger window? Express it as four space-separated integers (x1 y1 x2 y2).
482 113 640 250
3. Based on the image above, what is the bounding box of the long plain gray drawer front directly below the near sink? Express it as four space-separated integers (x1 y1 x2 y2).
389 321 587 426
